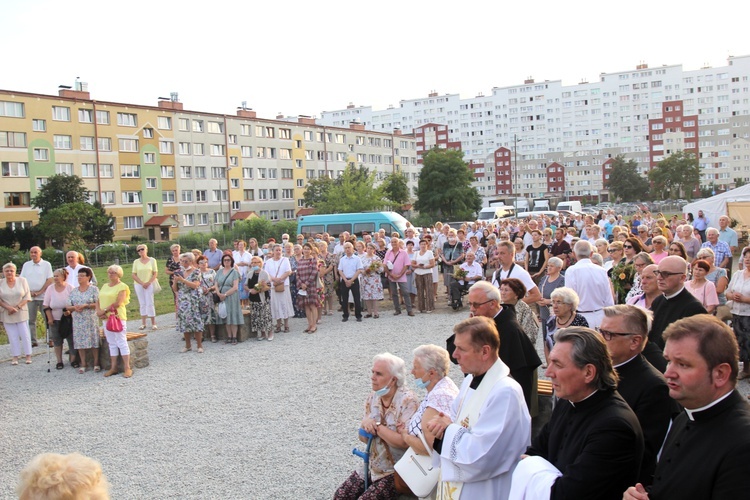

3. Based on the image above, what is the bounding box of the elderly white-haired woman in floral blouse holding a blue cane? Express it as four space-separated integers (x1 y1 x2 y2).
333 352 419 500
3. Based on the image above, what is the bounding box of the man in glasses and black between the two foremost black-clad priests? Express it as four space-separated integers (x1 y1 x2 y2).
599 305 679 485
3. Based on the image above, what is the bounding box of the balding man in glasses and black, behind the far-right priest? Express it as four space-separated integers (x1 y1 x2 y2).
643 255 706 373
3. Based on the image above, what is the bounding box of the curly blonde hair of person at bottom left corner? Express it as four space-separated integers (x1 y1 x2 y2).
16 453 109 500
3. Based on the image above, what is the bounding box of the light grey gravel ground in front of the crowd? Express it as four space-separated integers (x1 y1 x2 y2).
0 300 750 499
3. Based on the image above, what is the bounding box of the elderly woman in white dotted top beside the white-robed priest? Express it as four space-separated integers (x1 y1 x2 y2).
399 344 458 455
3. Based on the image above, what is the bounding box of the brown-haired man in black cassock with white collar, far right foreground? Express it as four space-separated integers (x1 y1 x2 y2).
623 314 750 500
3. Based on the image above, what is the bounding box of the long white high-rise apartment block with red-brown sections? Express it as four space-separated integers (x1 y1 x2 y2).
319 56 750 198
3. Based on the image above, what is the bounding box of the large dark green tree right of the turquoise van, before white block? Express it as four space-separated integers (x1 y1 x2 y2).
415 148 482 220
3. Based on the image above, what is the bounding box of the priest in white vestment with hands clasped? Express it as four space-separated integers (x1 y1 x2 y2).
426 317 531 500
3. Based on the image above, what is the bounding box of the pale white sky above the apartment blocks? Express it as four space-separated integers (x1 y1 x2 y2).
0 0 750 118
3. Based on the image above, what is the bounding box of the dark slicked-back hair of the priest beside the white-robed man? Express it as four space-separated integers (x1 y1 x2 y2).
555 326 619 391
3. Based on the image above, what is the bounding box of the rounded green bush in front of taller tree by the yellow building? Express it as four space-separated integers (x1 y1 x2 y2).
38 201 114 248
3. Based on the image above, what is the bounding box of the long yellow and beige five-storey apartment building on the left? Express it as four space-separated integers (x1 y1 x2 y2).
0 84 421 241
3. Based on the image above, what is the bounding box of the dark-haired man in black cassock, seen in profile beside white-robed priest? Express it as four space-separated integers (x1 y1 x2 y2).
524 327 643 500
